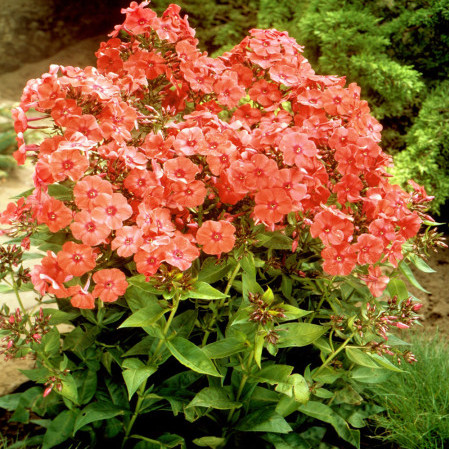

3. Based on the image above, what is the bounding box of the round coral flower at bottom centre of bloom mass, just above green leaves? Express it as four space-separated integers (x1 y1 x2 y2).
196 220 235 255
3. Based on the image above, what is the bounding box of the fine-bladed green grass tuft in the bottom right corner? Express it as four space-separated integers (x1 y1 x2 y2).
372 333 449 449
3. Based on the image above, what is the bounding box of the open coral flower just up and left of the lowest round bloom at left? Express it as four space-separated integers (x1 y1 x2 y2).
56 242 96 276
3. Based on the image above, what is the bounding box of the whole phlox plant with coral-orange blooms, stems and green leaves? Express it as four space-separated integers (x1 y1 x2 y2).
0 1 442 449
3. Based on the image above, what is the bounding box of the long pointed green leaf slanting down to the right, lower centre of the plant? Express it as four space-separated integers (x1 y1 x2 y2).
166 337 223 377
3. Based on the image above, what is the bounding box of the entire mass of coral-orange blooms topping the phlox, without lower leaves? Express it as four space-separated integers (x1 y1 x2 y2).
2 2 430 308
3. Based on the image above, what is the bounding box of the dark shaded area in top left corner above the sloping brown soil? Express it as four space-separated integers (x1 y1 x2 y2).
0 0 130 73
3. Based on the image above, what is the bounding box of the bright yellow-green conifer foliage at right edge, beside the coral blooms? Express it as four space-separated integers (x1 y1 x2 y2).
393 81 449 211
